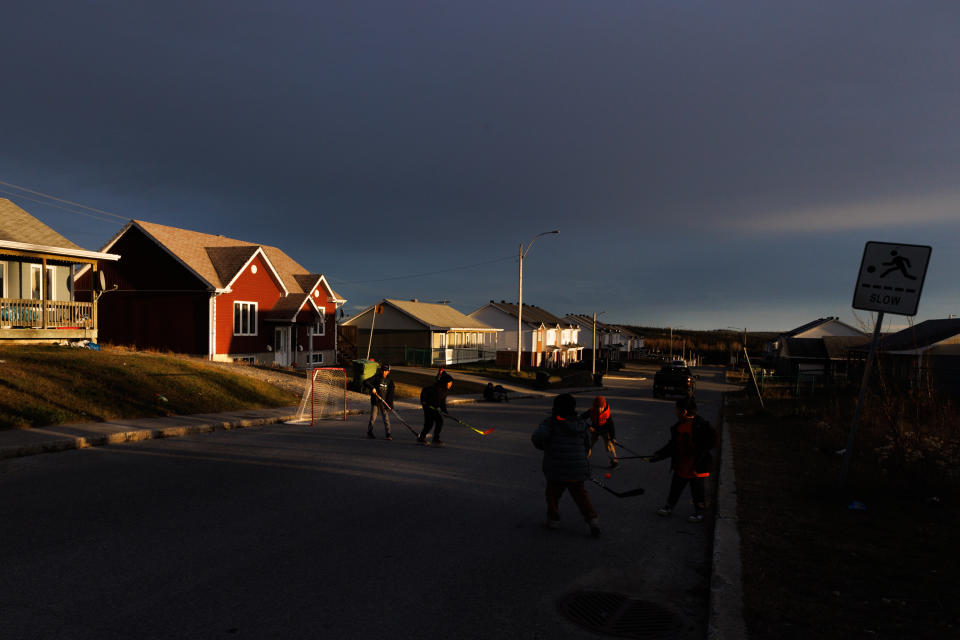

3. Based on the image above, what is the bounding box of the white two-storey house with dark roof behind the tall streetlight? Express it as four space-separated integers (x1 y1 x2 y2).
469 300 583 367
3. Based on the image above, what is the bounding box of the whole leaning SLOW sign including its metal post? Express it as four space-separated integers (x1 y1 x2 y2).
841 242 933 484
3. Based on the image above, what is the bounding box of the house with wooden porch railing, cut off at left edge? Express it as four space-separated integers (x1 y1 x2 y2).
0 198 120 344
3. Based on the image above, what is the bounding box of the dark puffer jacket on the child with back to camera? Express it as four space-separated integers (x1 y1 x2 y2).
530 414 590 482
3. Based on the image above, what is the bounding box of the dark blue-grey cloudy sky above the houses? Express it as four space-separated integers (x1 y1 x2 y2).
0 0 960 330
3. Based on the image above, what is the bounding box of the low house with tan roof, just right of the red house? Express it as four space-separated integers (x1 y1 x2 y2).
341 298 500 366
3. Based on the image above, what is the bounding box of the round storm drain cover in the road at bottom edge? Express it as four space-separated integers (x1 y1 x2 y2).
560 591 683 639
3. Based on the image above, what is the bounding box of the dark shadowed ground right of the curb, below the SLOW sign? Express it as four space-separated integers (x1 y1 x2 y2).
726 400 960 639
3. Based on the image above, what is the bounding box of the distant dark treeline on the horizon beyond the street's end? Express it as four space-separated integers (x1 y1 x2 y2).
626 325 778 364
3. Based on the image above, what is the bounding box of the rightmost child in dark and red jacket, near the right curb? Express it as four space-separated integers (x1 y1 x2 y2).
649 398 716 522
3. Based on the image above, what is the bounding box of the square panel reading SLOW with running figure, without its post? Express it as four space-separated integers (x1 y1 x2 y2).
853 242 933 316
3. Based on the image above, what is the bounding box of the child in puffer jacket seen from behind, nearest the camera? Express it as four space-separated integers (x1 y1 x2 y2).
530 393 600 537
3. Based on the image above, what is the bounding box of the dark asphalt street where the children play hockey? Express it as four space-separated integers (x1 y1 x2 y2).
0 368 723 639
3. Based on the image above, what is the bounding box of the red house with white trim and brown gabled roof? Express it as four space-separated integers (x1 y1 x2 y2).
77 220 345 367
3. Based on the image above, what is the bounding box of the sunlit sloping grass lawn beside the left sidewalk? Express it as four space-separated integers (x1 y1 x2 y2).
0 346 299 429
